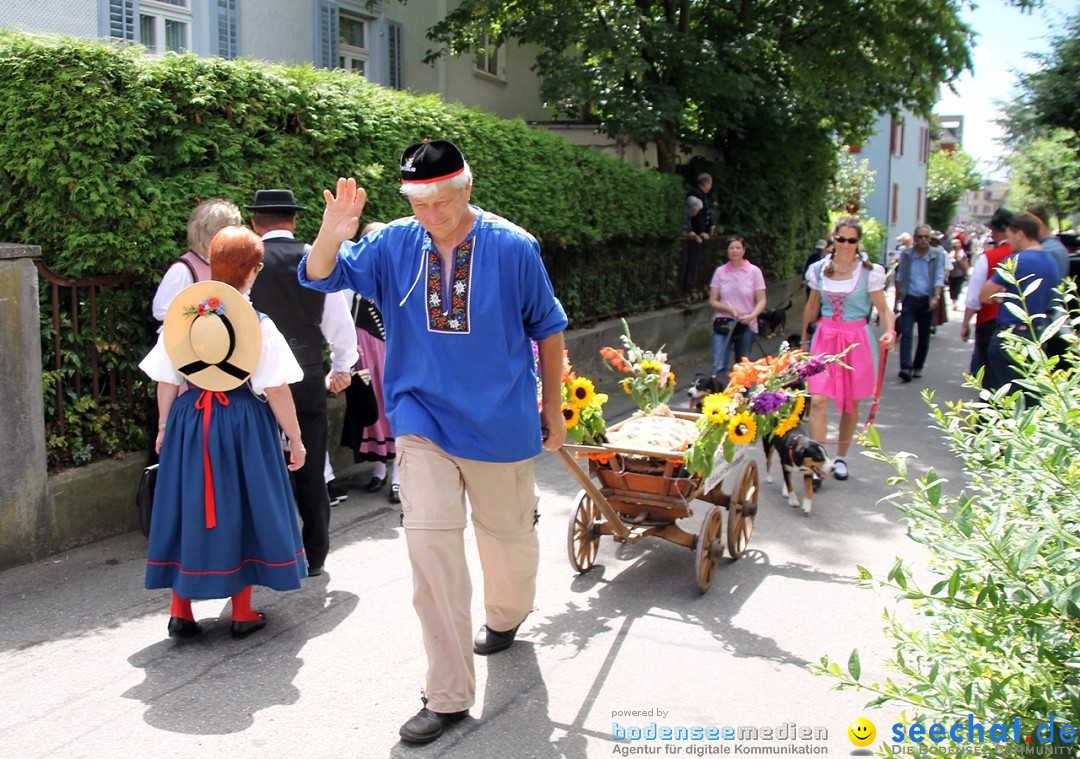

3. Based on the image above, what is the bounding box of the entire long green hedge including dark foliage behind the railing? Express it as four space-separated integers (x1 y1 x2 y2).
0 30 685 467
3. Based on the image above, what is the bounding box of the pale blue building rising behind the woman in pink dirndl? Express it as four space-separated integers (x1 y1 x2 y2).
851 110 930 261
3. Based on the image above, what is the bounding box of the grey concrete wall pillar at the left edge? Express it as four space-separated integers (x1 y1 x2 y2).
0 243 51 569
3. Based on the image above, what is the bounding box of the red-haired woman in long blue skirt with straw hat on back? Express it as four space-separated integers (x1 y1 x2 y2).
139 227 307 638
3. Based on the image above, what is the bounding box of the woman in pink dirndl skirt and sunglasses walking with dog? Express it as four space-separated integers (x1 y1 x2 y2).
802 216 896 479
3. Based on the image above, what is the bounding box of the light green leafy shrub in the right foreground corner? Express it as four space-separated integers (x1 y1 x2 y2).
815 276 1080 756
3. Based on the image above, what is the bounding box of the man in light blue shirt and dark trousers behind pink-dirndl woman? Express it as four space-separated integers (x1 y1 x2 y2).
894 226 945 382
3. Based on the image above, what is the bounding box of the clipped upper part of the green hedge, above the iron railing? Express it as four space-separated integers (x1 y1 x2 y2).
0 31 684 280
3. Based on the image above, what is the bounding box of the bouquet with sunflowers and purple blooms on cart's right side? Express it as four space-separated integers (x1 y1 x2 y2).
686 343 847 477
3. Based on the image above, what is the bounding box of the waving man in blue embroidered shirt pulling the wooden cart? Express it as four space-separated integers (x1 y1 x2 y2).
300 139 567 743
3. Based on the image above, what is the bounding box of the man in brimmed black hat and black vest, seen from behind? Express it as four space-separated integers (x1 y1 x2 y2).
246 190 359 577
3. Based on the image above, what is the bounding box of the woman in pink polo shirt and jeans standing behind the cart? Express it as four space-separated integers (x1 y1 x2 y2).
708 235 765 374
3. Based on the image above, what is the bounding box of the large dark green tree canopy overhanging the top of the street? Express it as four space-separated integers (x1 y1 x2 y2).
408 0 971 173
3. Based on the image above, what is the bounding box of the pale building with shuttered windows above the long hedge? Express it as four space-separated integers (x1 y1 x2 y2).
0 0 552 122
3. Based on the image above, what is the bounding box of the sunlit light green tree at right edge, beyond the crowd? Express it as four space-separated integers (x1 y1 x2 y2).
1009 130 1080 228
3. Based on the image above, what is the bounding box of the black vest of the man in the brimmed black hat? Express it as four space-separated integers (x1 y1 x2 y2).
252 238 326 366
